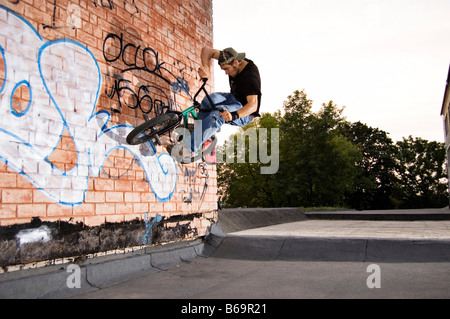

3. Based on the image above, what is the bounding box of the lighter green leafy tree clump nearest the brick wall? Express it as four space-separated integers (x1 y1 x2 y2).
218 91 360 207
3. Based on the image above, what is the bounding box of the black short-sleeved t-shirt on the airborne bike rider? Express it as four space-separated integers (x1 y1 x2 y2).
229 59 262 116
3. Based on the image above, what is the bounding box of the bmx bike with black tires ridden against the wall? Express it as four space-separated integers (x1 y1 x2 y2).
127 78 217 164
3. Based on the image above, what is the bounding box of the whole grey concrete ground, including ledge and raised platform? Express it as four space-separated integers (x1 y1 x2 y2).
0 209 450 299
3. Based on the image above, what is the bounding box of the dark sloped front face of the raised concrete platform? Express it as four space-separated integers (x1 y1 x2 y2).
211 235 450 262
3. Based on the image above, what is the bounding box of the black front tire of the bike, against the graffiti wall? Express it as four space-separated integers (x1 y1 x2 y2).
127 113 179 145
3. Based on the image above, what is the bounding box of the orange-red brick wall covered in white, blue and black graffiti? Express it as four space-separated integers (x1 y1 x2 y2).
0 0 217 248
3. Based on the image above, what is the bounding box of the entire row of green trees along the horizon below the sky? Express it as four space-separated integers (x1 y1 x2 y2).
218 91 448 209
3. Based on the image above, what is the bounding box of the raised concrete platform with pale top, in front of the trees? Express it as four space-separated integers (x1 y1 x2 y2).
208 208 450 262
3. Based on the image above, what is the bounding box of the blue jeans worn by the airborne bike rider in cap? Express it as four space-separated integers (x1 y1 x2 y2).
190 93 254 152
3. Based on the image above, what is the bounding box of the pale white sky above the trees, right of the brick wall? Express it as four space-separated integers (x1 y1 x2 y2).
213 0 450 142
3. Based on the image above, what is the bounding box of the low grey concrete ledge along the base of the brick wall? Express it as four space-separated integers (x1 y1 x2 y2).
0 239 205 299
